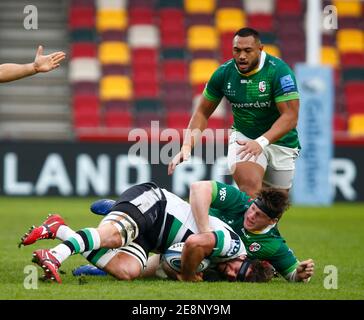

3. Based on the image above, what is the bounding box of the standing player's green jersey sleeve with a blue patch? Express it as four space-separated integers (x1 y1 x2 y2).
273 61 299 102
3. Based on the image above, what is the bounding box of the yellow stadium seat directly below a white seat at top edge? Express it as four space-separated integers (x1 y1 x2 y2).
96 9 128 32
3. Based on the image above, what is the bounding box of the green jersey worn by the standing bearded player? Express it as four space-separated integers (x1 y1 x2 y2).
203 51 300 148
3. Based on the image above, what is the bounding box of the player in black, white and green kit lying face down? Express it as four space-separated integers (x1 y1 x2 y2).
21 183 272 283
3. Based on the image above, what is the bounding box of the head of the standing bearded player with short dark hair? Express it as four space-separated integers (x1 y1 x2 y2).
233 28 263 73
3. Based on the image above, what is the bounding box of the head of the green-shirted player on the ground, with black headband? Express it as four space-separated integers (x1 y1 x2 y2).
244 188 289 231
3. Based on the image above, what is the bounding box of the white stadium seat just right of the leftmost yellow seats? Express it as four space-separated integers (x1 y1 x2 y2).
128 24 160 48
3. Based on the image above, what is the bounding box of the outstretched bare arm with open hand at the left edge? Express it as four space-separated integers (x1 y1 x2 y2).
0 46 66 82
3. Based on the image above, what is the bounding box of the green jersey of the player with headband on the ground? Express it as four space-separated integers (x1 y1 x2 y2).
209 181 299 276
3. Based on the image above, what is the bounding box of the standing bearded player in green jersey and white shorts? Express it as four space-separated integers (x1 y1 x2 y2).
168 28 300 196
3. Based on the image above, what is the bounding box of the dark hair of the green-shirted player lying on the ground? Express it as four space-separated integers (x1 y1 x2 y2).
254 188 290 219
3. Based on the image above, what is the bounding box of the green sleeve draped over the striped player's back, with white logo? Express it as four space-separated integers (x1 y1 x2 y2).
211 181 252 214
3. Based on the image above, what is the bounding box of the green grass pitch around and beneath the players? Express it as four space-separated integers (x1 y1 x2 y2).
0 197 364 300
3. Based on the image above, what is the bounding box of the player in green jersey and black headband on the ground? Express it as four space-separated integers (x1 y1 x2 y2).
190 181 314 282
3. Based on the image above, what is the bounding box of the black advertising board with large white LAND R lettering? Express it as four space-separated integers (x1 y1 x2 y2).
0 142 364 201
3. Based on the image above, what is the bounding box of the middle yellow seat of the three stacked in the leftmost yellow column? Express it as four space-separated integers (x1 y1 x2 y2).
99 41 130 64
